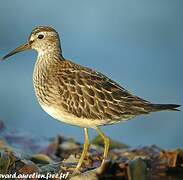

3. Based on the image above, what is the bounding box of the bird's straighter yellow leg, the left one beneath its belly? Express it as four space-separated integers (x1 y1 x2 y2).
75 128 89 172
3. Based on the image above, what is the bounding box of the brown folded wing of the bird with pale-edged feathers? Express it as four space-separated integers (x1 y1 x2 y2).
56 61 152 120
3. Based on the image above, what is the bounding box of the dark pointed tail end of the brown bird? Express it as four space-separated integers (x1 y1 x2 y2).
149 104 181 112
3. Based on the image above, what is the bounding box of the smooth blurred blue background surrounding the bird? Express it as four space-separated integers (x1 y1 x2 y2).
0 0 183 148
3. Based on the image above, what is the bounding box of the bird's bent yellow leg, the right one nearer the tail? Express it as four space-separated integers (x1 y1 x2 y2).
95 127 110 168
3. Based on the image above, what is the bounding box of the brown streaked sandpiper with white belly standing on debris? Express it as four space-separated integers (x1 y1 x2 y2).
2 26 180 171
